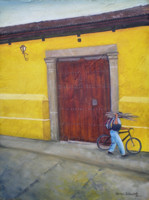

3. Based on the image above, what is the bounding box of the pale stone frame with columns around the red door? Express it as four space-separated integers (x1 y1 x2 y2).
45 44 119 141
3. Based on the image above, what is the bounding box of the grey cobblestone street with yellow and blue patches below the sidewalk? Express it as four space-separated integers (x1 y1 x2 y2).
0 148 149 200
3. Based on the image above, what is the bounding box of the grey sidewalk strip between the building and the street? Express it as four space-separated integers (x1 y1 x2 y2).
0 135 149 174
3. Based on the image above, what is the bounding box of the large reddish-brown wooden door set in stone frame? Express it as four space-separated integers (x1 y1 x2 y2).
57 56 111 142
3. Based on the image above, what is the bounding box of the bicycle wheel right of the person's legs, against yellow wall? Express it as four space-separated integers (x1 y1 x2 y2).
126 137 142 154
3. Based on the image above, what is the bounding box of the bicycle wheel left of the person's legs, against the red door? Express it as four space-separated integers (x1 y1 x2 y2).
97 135 111 150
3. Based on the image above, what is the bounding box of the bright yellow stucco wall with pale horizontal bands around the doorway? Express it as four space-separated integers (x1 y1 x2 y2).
0 27 149 151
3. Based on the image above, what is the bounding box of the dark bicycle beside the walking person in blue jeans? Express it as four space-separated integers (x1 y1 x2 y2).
97 128 142 154
